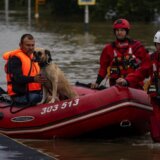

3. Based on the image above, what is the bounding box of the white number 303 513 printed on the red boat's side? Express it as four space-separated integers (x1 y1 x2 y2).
41 98 79 115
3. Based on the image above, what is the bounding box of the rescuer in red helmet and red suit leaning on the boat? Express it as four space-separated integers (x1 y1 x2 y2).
91 19 150 88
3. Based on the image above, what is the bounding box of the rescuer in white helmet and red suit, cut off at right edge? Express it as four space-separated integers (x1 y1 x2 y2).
148 31 160 142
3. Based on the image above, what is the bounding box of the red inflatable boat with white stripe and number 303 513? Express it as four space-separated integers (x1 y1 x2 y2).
0 86 152 139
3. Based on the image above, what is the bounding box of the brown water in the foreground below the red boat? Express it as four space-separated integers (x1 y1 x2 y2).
21 135 160 160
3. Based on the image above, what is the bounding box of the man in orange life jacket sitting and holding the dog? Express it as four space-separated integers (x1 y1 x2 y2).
3 34 46 105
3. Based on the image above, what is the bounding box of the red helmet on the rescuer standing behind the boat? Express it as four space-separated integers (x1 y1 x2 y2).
113 19 130 30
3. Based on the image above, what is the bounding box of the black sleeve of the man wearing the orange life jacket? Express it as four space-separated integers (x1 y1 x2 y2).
8 57 34 84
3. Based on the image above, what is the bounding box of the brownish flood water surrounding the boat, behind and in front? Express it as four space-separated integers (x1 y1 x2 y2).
0 9 160 160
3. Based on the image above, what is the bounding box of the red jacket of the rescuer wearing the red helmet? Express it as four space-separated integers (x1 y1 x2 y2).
98 39 151 88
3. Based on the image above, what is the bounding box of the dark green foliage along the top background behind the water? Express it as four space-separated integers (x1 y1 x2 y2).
0 0 160 22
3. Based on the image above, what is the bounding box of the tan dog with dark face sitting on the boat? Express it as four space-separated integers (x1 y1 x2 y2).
34 49 77 103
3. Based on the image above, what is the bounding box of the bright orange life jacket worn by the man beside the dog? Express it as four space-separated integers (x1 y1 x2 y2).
3 49 41 96
